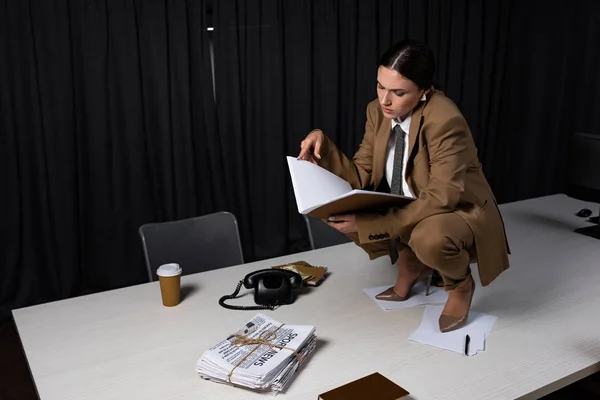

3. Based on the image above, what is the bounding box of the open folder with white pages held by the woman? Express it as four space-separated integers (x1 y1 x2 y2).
287 157 414 219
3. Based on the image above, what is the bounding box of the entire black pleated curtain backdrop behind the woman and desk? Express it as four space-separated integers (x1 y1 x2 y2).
0 0 600 313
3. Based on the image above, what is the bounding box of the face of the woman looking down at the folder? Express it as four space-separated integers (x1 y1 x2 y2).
377 66 425 119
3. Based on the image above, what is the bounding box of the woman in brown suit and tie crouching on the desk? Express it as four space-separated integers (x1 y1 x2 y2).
298 41 510 332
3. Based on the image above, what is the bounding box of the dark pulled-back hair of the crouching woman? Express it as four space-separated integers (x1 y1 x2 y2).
379 39 435 89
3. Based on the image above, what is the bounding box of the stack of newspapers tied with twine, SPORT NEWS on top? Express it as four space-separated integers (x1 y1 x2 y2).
196 313 317 393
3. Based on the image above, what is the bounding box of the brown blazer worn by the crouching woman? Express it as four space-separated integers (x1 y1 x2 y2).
319 90 510 286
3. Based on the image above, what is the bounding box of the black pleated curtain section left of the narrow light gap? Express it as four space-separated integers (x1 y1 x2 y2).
0 0 229 314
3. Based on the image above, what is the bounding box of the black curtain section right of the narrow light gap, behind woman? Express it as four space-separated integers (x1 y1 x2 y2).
214 0 600 257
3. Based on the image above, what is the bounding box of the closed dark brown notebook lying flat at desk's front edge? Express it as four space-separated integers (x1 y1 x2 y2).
319 372 409 400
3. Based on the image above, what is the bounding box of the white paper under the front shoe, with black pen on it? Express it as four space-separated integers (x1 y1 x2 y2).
408 306 497 356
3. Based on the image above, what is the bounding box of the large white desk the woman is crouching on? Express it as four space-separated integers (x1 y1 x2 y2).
14 195 600 400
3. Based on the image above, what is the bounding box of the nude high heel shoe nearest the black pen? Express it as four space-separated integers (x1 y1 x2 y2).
439 275 475 333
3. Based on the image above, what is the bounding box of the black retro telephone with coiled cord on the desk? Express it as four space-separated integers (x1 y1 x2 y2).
219 269 302 310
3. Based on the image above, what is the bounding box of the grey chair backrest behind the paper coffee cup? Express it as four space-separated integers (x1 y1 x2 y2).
139 211 244 281
